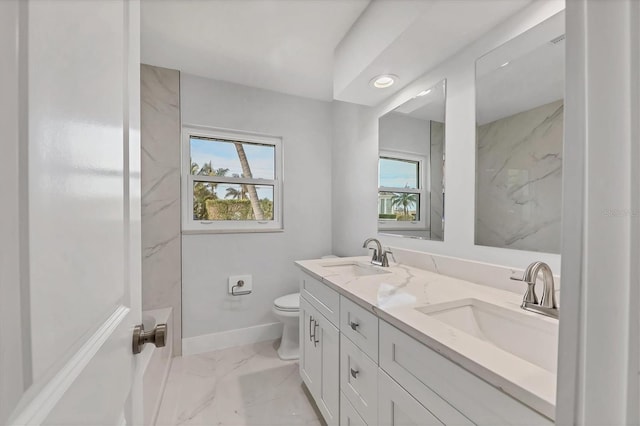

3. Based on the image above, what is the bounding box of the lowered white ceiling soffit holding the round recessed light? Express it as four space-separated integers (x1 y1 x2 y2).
333 0 531 106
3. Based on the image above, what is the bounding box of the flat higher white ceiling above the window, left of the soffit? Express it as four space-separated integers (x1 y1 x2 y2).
141 0 370 100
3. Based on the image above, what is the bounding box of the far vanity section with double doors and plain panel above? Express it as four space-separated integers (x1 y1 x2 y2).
299 275 340 425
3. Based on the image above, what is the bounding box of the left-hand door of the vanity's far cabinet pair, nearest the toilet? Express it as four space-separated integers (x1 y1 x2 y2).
299 297 321 401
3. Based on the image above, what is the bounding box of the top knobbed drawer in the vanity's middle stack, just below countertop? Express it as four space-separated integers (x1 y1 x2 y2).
340 296 378 362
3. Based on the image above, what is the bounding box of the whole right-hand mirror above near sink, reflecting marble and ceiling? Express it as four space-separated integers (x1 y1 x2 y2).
475 12 565 253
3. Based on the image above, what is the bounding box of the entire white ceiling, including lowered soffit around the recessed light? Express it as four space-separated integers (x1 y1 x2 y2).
141 0 531 105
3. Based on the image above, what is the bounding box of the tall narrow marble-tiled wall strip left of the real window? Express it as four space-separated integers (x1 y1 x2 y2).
140 65 182 355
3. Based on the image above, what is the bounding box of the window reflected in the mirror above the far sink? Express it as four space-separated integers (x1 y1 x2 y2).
378 151 428 230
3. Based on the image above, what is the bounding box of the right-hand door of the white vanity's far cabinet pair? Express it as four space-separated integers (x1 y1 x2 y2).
314 315 340 425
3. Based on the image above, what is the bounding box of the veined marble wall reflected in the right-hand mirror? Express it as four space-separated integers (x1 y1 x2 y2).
475 100 564 253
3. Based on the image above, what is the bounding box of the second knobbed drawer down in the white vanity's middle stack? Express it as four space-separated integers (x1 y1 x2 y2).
340 334 378 425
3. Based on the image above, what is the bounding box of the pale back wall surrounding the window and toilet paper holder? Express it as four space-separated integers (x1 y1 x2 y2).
181 74 332 342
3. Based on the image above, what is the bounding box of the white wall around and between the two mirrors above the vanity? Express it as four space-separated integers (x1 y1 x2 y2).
333 0 564 273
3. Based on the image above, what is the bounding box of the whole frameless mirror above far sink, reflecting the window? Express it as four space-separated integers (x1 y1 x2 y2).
378 80 447 241
